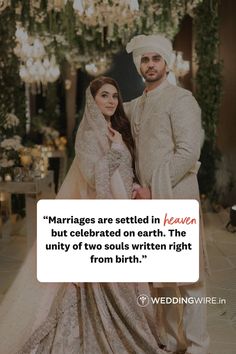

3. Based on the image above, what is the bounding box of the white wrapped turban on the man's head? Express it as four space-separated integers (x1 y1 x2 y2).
126 34 172 75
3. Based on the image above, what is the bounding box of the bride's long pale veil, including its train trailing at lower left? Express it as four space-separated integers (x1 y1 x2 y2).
0 88 133 354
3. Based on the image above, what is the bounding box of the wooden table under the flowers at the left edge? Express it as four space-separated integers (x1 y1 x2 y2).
0 171 55 247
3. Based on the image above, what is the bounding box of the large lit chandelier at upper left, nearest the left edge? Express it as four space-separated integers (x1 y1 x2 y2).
14 27 60 91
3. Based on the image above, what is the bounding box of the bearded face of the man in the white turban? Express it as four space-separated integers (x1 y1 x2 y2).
140 52 167 82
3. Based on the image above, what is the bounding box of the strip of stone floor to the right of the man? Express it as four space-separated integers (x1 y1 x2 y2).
204 210 236 354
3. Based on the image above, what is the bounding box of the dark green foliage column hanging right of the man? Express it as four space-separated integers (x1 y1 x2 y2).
195 0 222 201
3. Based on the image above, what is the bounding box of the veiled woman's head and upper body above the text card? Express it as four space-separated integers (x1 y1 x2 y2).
57 77 134 199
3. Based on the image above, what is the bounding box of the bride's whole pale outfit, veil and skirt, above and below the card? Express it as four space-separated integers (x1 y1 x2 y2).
0 89 170 354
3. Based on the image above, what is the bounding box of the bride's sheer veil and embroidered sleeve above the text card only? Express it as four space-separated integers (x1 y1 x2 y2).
57 88 133 199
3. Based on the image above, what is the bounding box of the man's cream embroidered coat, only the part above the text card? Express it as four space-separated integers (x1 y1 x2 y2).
126 81 202 199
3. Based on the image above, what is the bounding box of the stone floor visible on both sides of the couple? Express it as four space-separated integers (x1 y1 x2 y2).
0 209 236 354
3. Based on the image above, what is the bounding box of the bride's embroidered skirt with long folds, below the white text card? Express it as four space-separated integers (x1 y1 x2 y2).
19 283 164 354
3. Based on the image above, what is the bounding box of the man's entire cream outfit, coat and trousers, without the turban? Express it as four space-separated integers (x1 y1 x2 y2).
125 80 208 354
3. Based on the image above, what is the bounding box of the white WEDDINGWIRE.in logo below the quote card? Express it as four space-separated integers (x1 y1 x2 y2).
137 294 226 307
